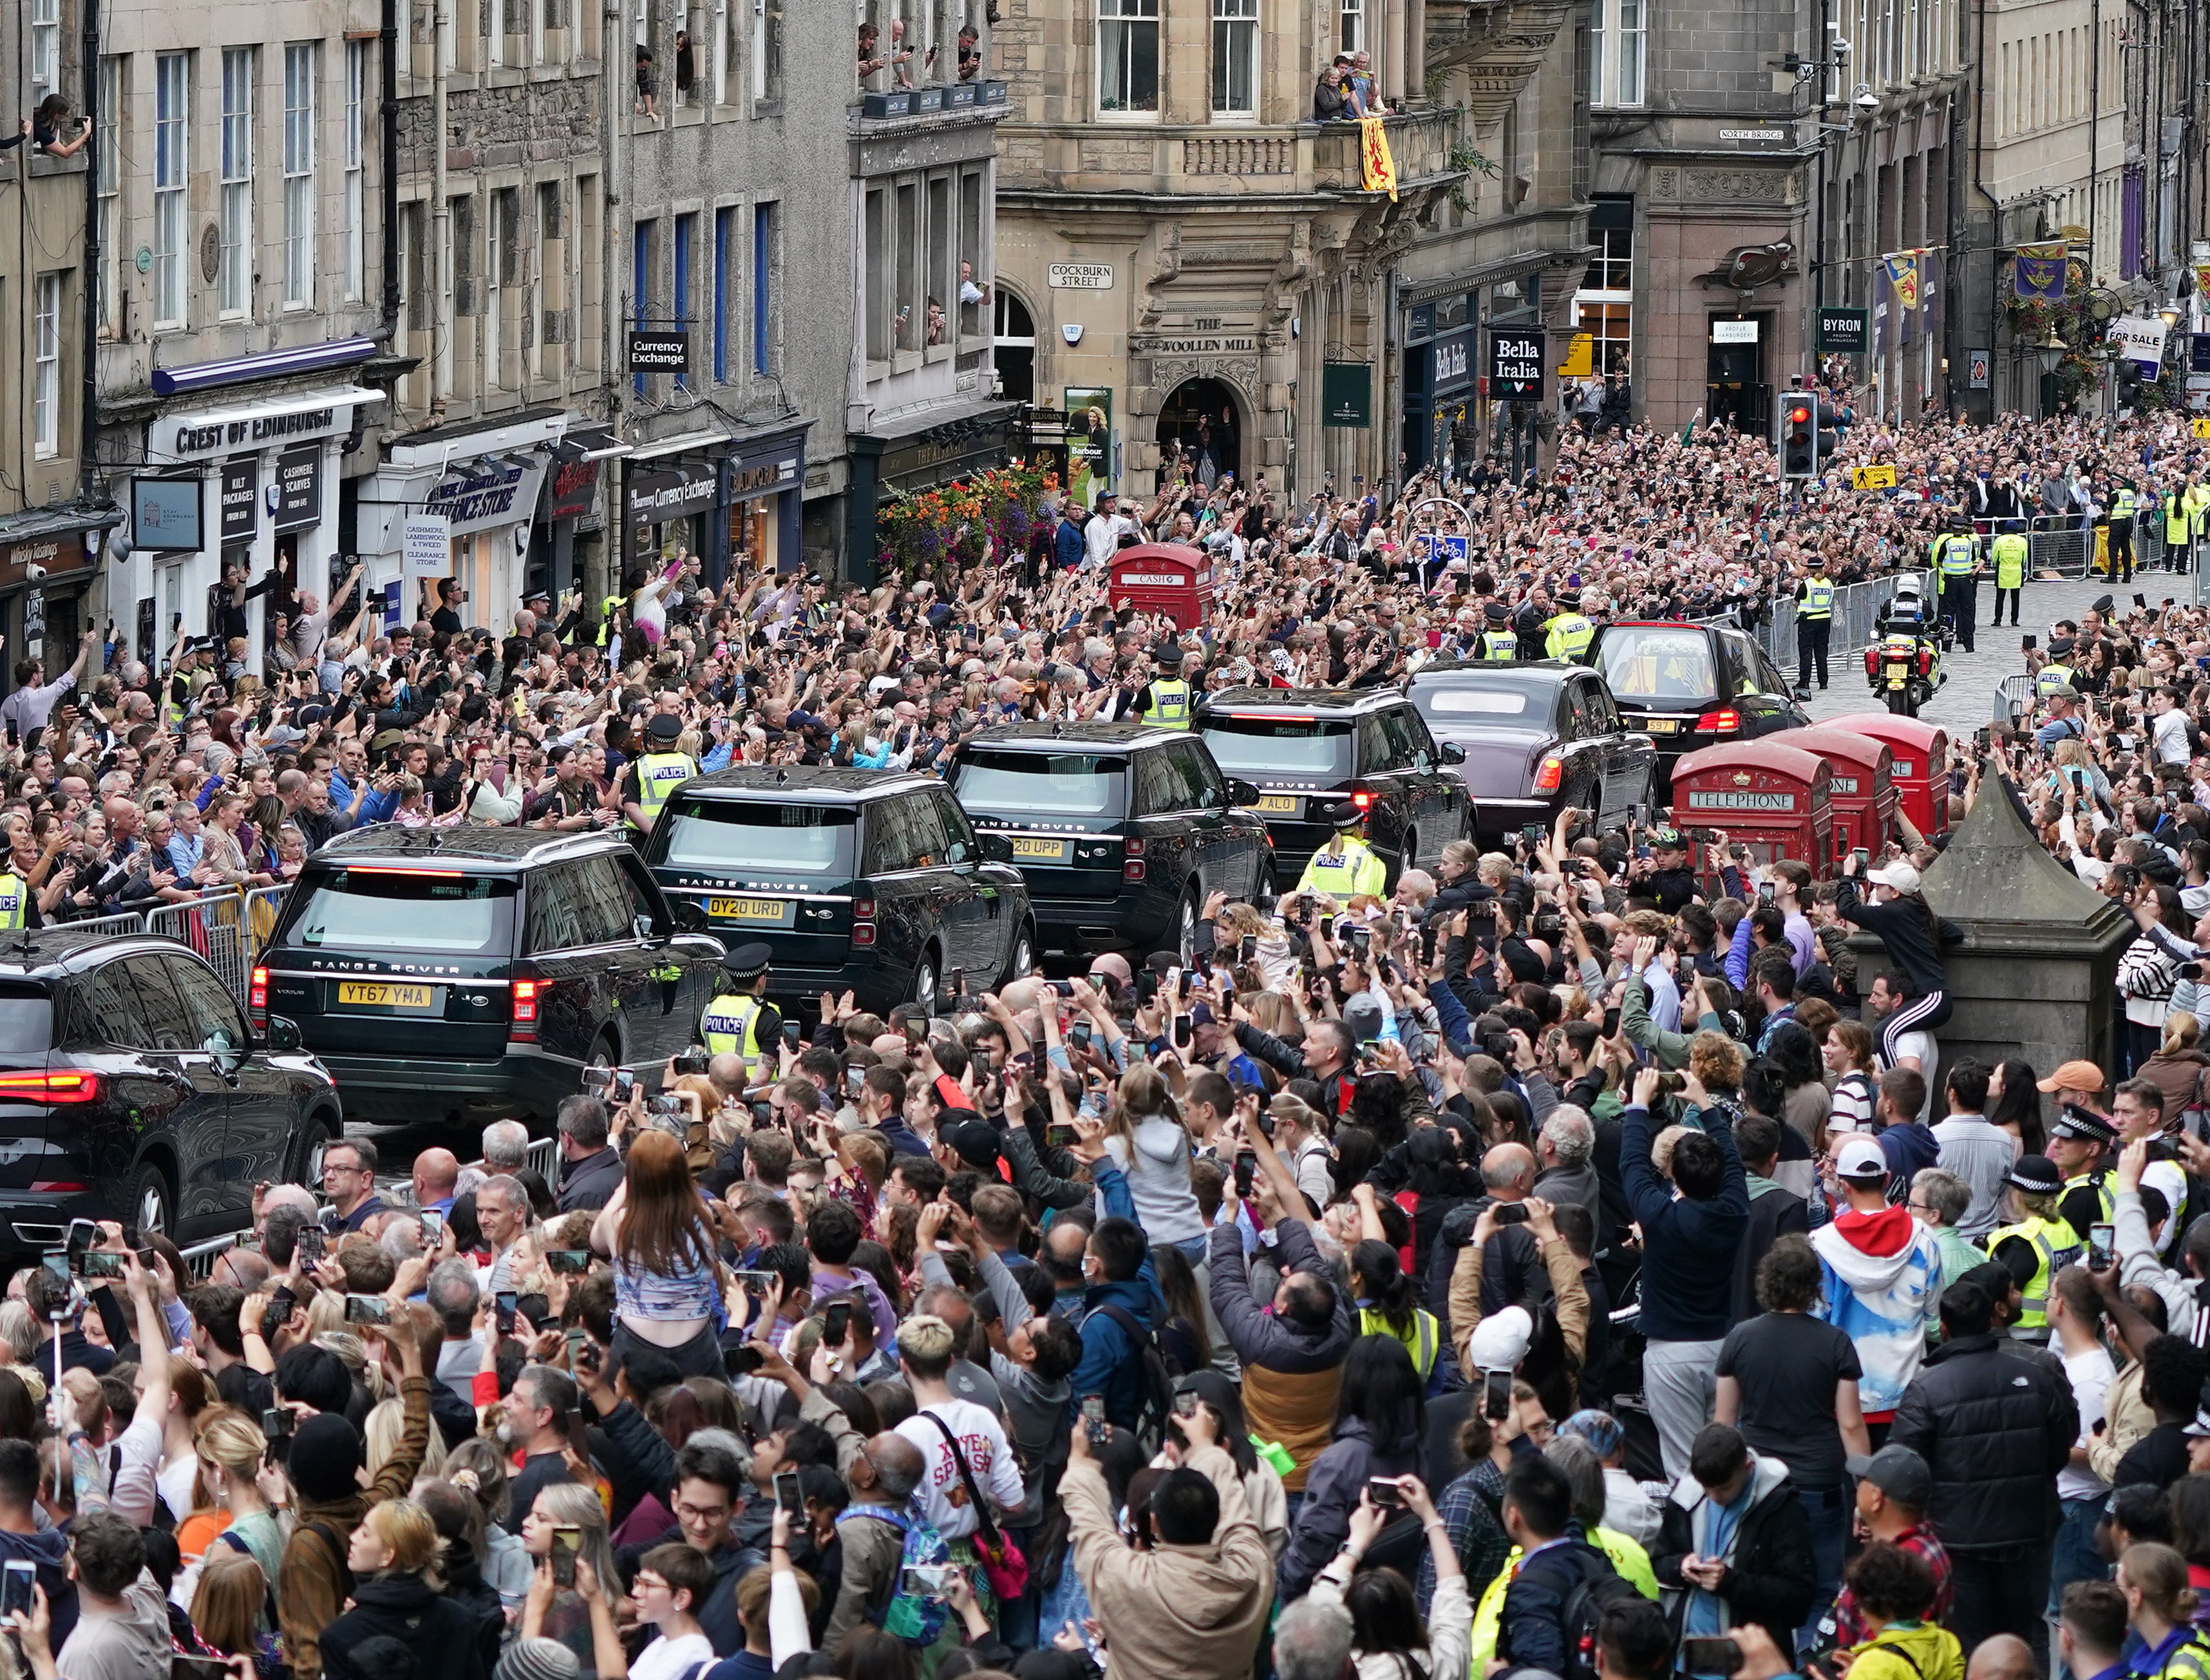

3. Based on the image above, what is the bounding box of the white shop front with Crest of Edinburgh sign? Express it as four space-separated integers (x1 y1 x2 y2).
128 384 384 663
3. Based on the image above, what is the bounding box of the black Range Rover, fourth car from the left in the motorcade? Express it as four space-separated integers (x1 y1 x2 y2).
946 723 1273 955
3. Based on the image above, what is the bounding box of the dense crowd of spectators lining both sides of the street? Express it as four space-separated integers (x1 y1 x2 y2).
17 397 2210 1680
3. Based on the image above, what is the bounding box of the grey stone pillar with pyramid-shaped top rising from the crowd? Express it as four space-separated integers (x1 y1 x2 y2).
1850 760 2135 1088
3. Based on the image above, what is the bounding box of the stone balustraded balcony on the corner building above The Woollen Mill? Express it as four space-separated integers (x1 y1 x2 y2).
1016 111 1459 197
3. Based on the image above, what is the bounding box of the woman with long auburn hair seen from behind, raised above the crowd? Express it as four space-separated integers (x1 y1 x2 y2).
590 1132 730 1377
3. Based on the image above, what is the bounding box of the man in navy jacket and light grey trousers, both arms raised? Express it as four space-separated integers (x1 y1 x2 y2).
1620 1068 1750 1481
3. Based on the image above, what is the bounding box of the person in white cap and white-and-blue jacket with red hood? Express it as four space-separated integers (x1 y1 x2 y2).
1810 1132 1940 1424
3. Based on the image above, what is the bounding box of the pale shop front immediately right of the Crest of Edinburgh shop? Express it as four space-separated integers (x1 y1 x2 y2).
360 409 577 632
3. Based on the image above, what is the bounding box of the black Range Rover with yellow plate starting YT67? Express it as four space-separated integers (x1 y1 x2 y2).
250 824 722 1123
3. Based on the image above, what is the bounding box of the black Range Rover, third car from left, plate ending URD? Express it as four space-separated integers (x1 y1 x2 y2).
645 765 1037 1012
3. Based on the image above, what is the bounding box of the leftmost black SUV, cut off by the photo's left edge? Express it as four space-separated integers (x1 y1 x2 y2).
0 929 341 1253
